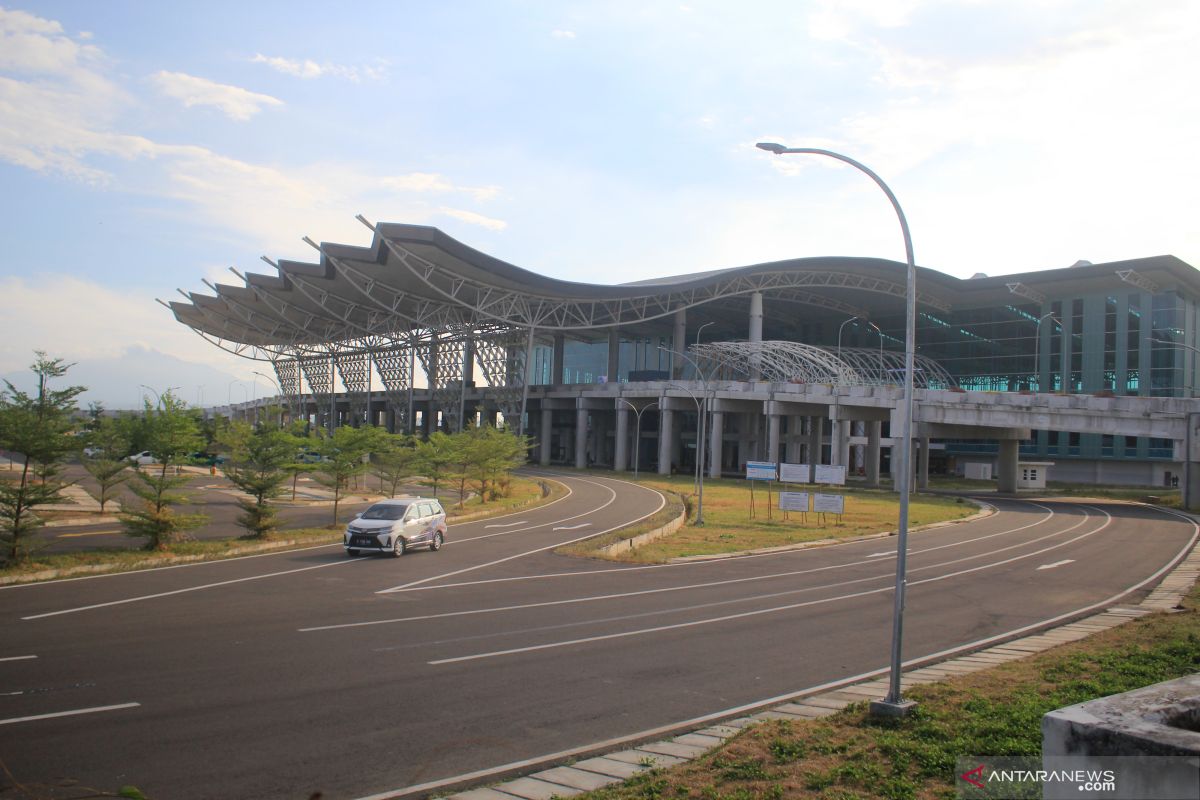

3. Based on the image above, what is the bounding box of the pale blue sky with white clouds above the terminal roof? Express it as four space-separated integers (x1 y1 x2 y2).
0 0 1200 407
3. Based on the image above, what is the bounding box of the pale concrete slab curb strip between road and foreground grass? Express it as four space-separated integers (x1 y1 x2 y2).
436 504 1200 800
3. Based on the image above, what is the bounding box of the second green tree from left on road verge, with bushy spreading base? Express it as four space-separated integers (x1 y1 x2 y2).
121 391 208 551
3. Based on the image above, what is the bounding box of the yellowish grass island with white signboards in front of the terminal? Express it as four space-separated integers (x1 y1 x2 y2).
568 474 978 563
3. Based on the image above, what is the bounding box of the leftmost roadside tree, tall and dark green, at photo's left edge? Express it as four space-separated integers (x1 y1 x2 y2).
0 350 84 563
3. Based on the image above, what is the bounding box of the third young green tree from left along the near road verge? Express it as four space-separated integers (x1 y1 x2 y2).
220 422 296 539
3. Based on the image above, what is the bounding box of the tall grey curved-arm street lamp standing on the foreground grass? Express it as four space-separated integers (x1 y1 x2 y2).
757 142 917 716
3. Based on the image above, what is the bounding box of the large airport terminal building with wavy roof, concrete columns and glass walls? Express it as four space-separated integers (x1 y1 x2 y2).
169 221 1200 486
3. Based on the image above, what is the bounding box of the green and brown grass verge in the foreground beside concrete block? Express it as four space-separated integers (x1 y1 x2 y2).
580 588 1200 800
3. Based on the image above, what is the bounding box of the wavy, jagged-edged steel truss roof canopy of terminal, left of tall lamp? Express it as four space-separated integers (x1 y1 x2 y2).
169 217 964 360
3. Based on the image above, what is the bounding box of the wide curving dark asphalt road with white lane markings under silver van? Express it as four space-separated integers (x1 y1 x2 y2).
0 476 1196 800
